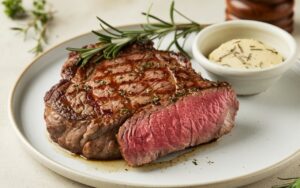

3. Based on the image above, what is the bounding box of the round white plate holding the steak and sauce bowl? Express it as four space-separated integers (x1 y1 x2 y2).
9 26 300 187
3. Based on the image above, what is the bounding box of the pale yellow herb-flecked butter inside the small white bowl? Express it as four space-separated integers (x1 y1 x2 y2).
209 39 284 69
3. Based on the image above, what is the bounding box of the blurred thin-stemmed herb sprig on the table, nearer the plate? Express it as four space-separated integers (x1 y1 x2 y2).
11 0 54 55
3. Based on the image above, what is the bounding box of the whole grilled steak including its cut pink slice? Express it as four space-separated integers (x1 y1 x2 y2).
44 42 238 163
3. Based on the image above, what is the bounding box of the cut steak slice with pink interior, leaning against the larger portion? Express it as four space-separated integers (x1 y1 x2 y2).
118 84 238 166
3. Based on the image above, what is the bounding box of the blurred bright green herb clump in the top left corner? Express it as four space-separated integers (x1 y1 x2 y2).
2 0 26 19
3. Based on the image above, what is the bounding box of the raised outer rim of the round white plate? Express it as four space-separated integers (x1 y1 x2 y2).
8 23 300 187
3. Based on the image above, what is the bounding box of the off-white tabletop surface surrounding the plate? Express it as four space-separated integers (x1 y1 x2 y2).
0 0 300 188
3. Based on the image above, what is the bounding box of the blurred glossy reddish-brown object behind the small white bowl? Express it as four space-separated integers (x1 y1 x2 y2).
226 0 294 33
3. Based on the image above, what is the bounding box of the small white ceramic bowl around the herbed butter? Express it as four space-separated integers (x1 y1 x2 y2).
192 20 297 95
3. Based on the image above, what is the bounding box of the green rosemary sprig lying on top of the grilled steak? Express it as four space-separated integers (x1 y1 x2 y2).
67 1 205 66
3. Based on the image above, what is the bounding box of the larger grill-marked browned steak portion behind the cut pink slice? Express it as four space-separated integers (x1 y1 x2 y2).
44 42 239 162
